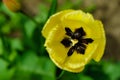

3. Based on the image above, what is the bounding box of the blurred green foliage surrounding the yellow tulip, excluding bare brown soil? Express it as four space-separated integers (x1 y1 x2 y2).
0 0 120 80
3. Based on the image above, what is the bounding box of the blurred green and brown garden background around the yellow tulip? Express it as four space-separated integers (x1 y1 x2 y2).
0 0 120 80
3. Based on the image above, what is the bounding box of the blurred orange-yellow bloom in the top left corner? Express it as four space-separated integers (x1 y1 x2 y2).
3 0 21 12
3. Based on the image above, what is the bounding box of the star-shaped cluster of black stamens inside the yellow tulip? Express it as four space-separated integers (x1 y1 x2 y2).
61 27 93 56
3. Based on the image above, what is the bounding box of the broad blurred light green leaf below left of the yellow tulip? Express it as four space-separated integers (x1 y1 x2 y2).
19 51 55 80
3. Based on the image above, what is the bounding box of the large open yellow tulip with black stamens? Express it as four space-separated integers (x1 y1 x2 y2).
42 10 106 72
